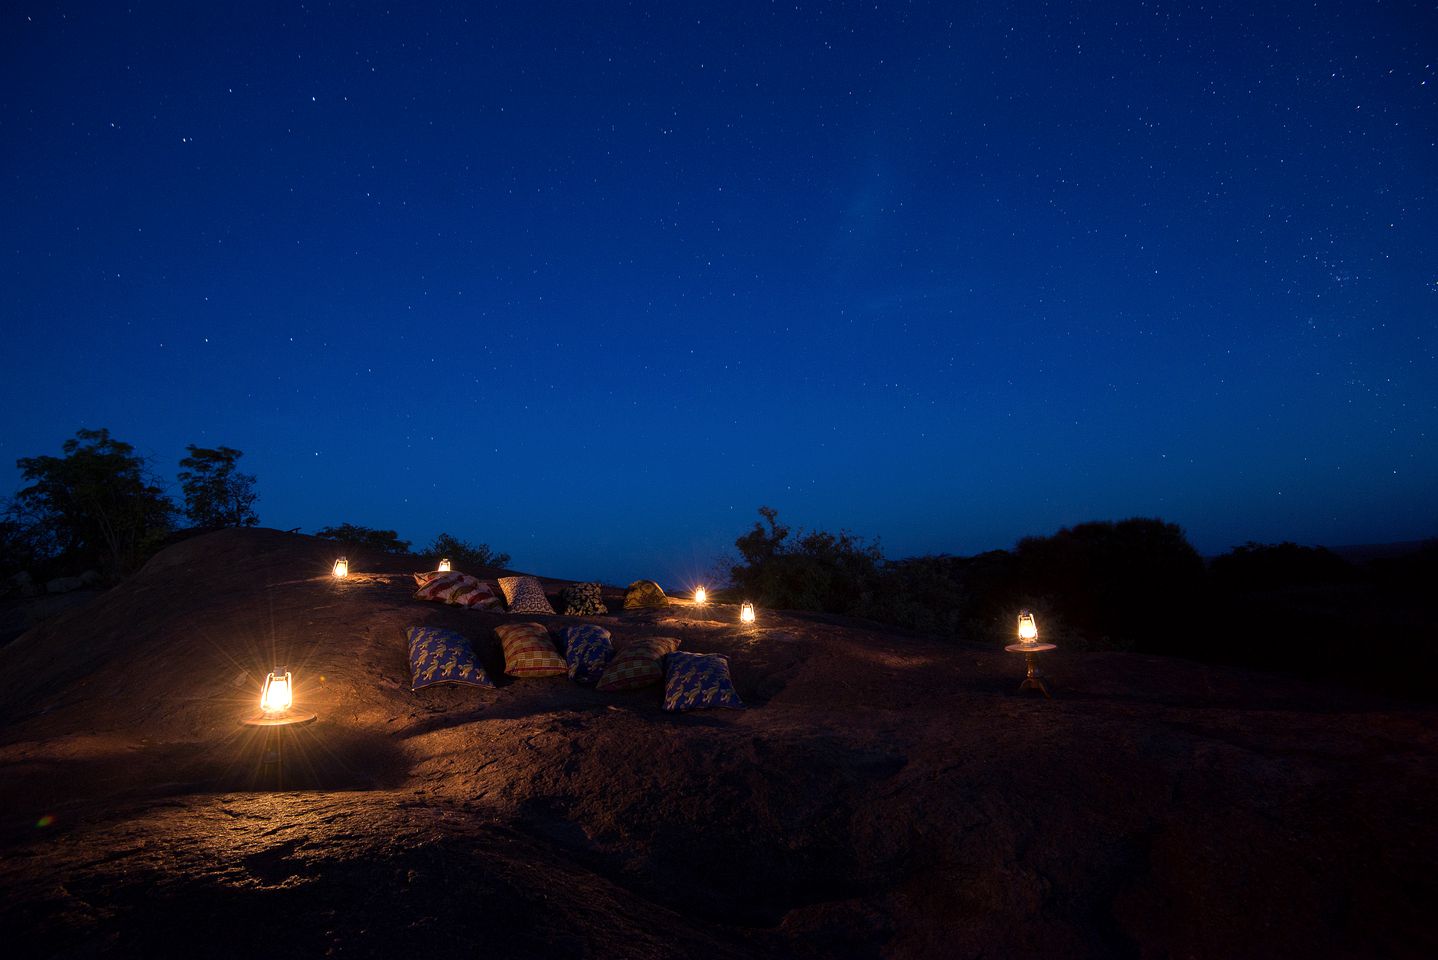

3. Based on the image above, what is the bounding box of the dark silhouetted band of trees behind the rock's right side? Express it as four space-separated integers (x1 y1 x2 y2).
728 507 1438 697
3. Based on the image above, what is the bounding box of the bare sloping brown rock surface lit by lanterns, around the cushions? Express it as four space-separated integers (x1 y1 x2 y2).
0 530 1438 960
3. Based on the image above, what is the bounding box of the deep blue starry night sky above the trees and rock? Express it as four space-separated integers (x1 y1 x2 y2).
0 1 1438 586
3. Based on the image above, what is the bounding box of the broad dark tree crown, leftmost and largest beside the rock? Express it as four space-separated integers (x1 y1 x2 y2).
7 430 175 578
